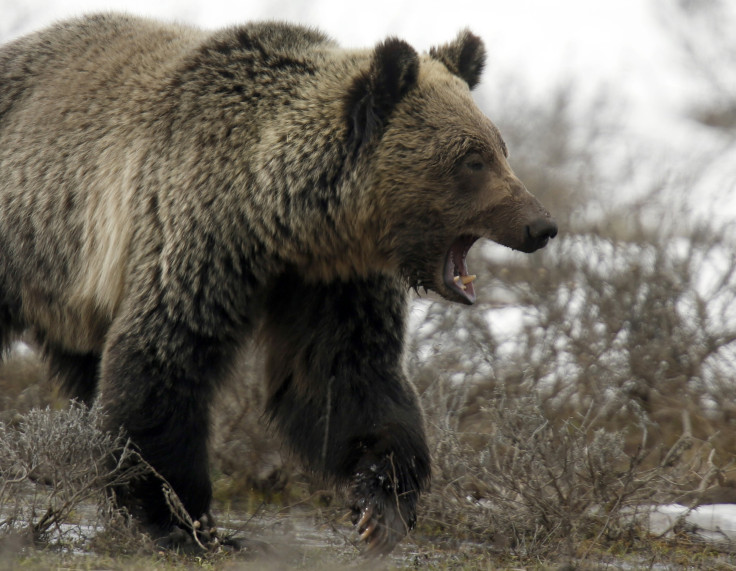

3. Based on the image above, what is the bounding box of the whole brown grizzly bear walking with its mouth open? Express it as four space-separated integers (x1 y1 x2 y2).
0 15 557 554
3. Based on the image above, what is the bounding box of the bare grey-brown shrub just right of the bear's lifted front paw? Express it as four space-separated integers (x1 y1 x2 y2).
421 379 716 559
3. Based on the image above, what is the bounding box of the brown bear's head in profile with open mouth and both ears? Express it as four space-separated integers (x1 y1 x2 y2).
345 31 557 304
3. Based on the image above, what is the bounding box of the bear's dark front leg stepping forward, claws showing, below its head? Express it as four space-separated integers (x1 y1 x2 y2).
264 274 430 555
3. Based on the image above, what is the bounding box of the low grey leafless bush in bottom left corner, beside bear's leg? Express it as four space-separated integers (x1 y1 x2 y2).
0 403 146 542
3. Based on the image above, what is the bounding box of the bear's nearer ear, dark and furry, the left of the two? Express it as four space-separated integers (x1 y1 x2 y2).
345 38 419 151
